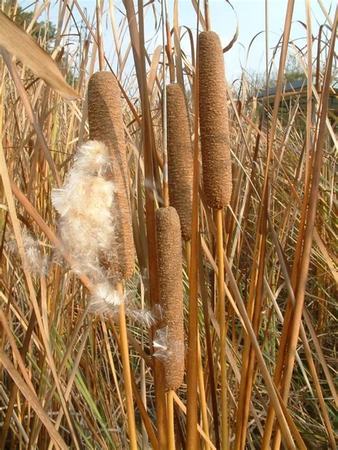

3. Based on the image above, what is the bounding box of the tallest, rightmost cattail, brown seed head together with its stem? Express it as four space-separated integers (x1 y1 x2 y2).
198 31 232 449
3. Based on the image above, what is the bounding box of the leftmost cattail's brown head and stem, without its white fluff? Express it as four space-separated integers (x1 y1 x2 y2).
88 72 137 450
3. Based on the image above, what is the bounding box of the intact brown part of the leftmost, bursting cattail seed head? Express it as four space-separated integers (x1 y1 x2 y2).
88 72 135 281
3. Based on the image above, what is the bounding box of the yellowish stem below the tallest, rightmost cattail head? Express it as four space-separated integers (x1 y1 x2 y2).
215 209 229 450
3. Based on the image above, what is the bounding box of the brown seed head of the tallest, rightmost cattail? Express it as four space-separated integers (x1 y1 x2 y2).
199 31 232 209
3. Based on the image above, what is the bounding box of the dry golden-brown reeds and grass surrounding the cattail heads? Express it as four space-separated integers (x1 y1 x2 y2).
0 0 338 450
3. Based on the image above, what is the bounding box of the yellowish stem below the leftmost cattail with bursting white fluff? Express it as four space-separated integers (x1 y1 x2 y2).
117 283 137 450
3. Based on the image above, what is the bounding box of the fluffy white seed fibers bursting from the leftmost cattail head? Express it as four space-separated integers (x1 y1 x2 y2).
52 141 123 314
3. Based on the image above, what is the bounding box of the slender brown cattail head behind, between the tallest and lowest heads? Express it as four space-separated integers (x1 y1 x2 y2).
167 84 193 241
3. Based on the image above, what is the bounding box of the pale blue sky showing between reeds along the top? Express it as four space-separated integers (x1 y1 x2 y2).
20 0 335 81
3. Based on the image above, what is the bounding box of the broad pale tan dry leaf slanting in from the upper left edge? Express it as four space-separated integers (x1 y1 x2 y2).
0 11 78 99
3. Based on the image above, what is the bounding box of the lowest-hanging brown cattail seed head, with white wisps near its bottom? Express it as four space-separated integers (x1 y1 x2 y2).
156 206 184 390
